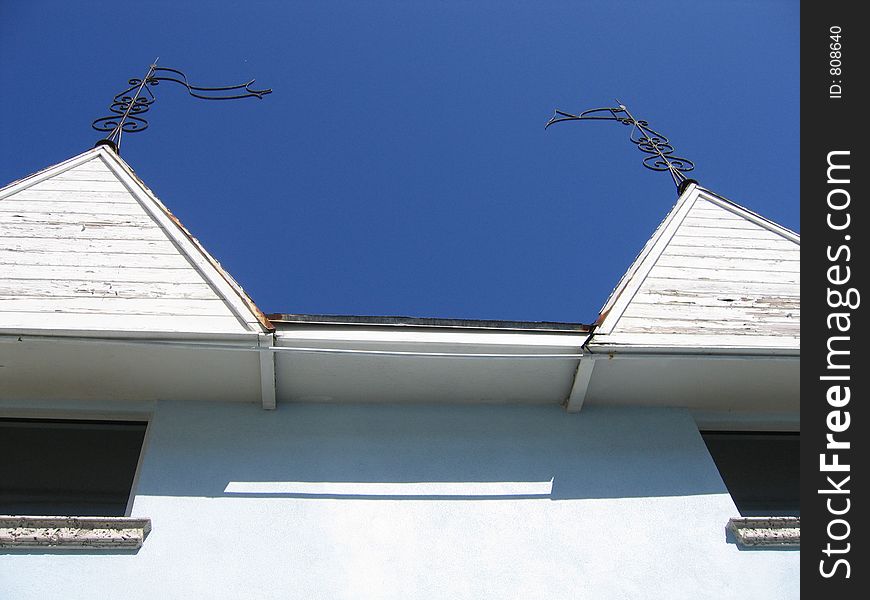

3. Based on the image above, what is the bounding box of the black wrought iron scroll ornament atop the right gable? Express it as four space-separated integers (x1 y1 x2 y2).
544 100 695 190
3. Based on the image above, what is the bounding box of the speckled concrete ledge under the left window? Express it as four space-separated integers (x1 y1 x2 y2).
0 515 151 550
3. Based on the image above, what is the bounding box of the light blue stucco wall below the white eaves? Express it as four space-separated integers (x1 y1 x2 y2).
0 402 799 600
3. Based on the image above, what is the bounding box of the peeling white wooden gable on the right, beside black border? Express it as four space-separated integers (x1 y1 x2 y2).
589 184 800 354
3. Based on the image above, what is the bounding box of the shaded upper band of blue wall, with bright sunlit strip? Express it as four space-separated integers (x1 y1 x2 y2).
136 402 727 500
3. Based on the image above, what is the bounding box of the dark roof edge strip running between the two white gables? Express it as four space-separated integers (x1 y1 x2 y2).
266 313 592 333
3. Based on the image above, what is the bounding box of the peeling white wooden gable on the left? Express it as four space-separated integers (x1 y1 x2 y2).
0 146 268 337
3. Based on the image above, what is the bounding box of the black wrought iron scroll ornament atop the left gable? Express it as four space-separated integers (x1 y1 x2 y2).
91 60 272 150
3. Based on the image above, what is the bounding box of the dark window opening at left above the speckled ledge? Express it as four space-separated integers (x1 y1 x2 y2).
0 419 147 517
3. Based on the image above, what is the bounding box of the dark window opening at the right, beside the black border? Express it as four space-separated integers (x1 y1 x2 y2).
701 431 800 517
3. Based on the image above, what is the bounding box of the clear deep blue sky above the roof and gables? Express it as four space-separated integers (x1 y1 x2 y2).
0 0 800 323
